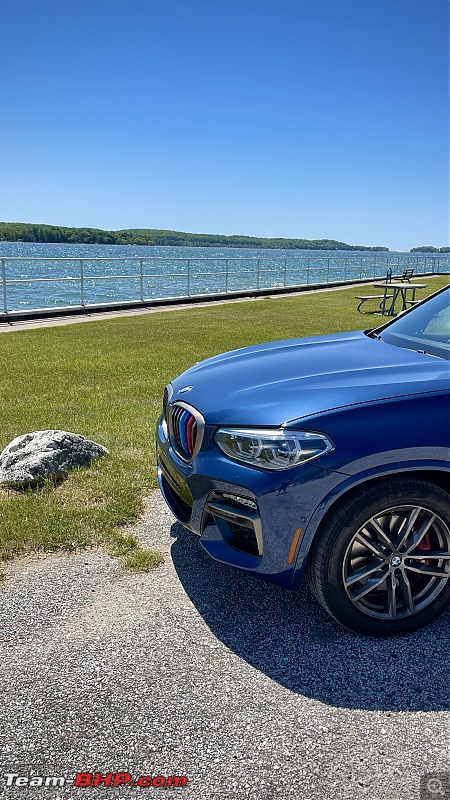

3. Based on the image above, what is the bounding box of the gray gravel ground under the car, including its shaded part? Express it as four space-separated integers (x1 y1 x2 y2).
0 493 450 800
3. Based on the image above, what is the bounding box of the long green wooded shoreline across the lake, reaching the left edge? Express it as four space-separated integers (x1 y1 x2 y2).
0 222 389 251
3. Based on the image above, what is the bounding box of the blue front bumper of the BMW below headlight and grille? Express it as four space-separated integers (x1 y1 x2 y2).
156 419 345 586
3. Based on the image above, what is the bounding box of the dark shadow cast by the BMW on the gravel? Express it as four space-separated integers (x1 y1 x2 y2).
171 523 450 711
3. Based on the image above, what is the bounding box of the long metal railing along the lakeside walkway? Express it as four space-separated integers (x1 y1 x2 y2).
0 253 449 314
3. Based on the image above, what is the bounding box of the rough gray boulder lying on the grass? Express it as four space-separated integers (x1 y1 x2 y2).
0 431 108 486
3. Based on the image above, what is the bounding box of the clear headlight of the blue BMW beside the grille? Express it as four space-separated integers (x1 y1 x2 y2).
215 428 333 469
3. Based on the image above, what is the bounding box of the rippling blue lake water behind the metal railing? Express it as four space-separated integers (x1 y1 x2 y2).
0 242 449 311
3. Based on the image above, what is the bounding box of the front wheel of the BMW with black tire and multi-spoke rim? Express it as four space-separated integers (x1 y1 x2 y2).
308 478 450 636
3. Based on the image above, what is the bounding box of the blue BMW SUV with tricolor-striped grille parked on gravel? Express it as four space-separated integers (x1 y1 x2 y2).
157 287 450 636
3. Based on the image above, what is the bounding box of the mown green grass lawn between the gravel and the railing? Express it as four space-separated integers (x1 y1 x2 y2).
0 276 449 569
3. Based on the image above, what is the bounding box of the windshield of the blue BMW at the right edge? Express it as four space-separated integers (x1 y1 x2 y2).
372 287 450 360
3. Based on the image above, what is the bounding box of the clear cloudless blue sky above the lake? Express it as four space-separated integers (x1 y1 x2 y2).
0 0 449 250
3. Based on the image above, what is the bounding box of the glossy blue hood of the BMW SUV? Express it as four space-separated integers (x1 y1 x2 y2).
172 331 449 426
